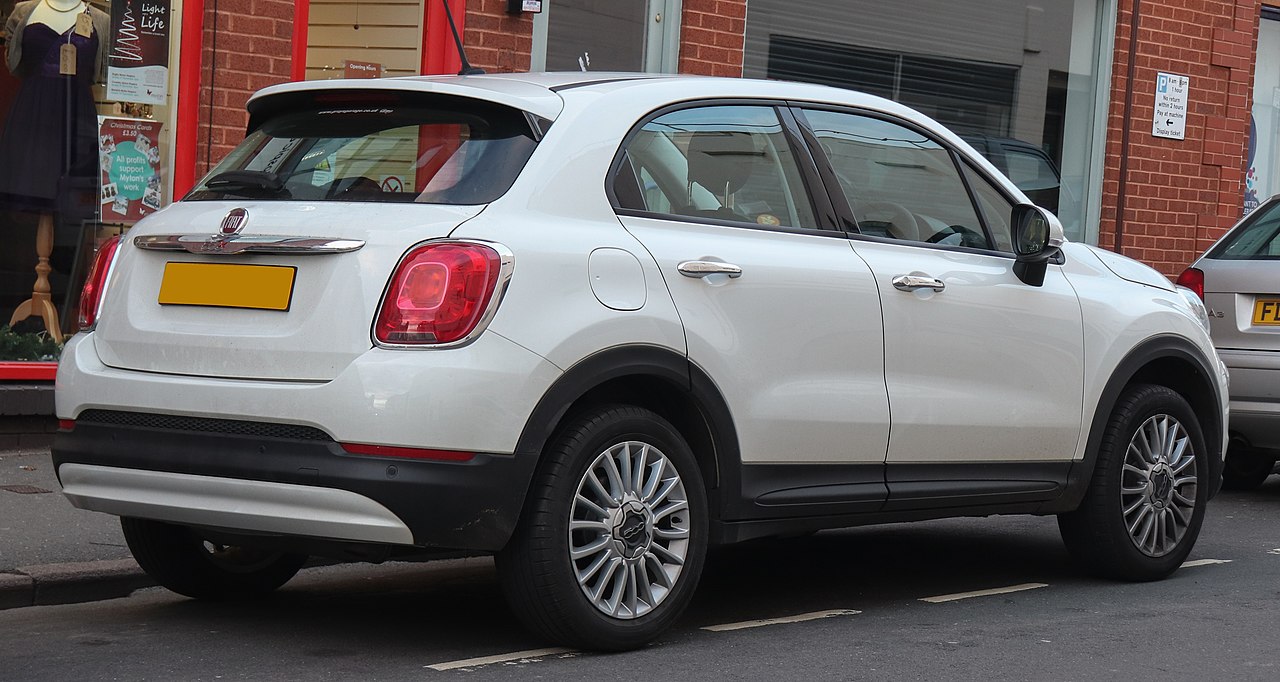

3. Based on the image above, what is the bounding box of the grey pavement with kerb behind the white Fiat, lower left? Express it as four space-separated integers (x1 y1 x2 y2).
0 448 155 609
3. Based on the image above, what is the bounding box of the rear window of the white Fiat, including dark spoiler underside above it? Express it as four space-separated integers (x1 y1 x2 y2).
186 91 536 205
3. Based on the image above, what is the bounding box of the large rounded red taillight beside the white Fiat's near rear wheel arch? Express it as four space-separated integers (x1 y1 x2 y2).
374 242 502 344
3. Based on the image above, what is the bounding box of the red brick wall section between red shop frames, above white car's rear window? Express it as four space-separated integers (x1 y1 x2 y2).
196 0 293 175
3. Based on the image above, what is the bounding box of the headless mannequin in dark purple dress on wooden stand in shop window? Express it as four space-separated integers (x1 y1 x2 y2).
0 0 109 342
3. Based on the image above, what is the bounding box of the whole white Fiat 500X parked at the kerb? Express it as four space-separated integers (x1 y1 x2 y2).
54 73 1228 650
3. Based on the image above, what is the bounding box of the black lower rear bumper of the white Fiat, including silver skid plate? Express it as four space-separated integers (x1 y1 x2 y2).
52 413 535 551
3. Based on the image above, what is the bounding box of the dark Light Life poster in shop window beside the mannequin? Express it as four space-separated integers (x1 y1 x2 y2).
106 0 169 104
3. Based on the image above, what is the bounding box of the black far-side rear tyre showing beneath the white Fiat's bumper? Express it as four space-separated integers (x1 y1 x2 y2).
120 517 307 599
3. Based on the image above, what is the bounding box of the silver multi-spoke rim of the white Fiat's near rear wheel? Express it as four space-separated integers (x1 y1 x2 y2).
568 441 690 619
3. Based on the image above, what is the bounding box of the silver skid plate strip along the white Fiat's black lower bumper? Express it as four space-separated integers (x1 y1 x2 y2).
58 463 413 545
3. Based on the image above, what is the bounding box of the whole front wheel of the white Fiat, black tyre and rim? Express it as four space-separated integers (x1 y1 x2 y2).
1059 384 1210 581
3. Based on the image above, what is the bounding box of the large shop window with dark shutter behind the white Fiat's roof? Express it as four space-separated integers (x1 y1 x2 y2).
744 0 1116 242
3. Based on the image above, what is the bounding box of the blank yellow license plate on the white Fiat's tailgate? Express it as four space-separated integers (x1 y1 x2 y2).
159 262 297 310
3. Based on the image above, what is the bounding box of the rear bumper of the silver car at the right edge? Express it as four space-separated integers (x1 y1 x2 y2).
1219 351 1280 449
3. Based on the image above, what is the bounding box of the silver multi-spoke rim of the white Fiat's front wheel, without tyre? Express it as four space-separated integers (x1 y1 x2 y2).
1120 415 1198 557
